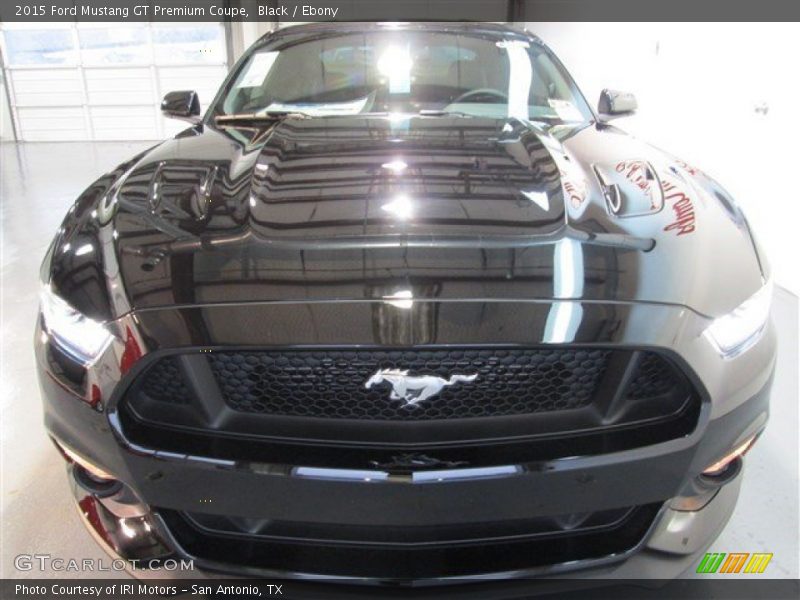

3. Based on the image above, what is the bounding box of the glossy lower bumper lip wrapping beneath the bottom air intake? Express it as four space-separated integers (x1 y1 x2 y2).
70 458 742 585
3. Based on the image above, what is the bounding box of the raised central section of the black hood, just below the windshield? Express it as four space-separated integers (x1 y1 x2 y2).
249 118 564 240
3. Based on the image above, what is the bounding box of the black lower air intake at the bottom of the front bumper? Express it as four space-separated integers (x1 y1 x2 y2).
158 503 661 580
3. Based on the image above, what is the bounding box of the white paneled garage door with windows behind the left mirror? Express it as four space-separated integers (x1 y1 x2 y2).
2 23 227 142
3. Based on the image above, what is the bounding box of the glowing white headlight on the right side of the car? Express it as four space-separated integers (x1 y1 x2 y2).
706 281 772 357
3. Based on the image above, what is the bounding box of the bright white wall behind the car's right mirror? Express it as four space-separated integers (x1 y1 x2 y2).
527 23 800 294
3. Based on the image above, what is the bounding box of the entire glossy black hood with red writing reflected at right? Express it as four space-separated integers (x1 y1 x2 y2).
48 116 762 318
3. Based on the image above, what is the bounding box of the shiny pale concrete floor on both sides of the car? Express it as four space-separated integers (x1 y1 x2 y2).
0 143 800 578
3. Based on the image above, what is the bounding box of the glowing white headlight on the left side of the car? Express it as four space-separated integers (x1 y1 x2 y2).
40 285 113 364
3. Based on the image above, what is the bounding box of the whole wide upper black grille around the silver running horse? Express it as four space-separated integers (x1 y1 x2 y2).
121 346 700 468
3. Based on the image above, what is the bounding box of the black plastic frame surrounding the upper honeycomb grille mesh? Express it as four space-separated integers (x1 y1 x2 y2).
117 344 708 469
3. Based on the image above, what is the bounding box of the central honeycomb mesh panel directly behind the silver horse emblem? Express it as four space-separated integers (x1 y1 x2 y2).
209 349 610 421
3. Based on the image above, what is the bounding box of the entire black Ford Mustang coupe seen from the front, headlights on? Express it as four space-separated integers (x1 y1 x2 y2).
35 23 775 583
